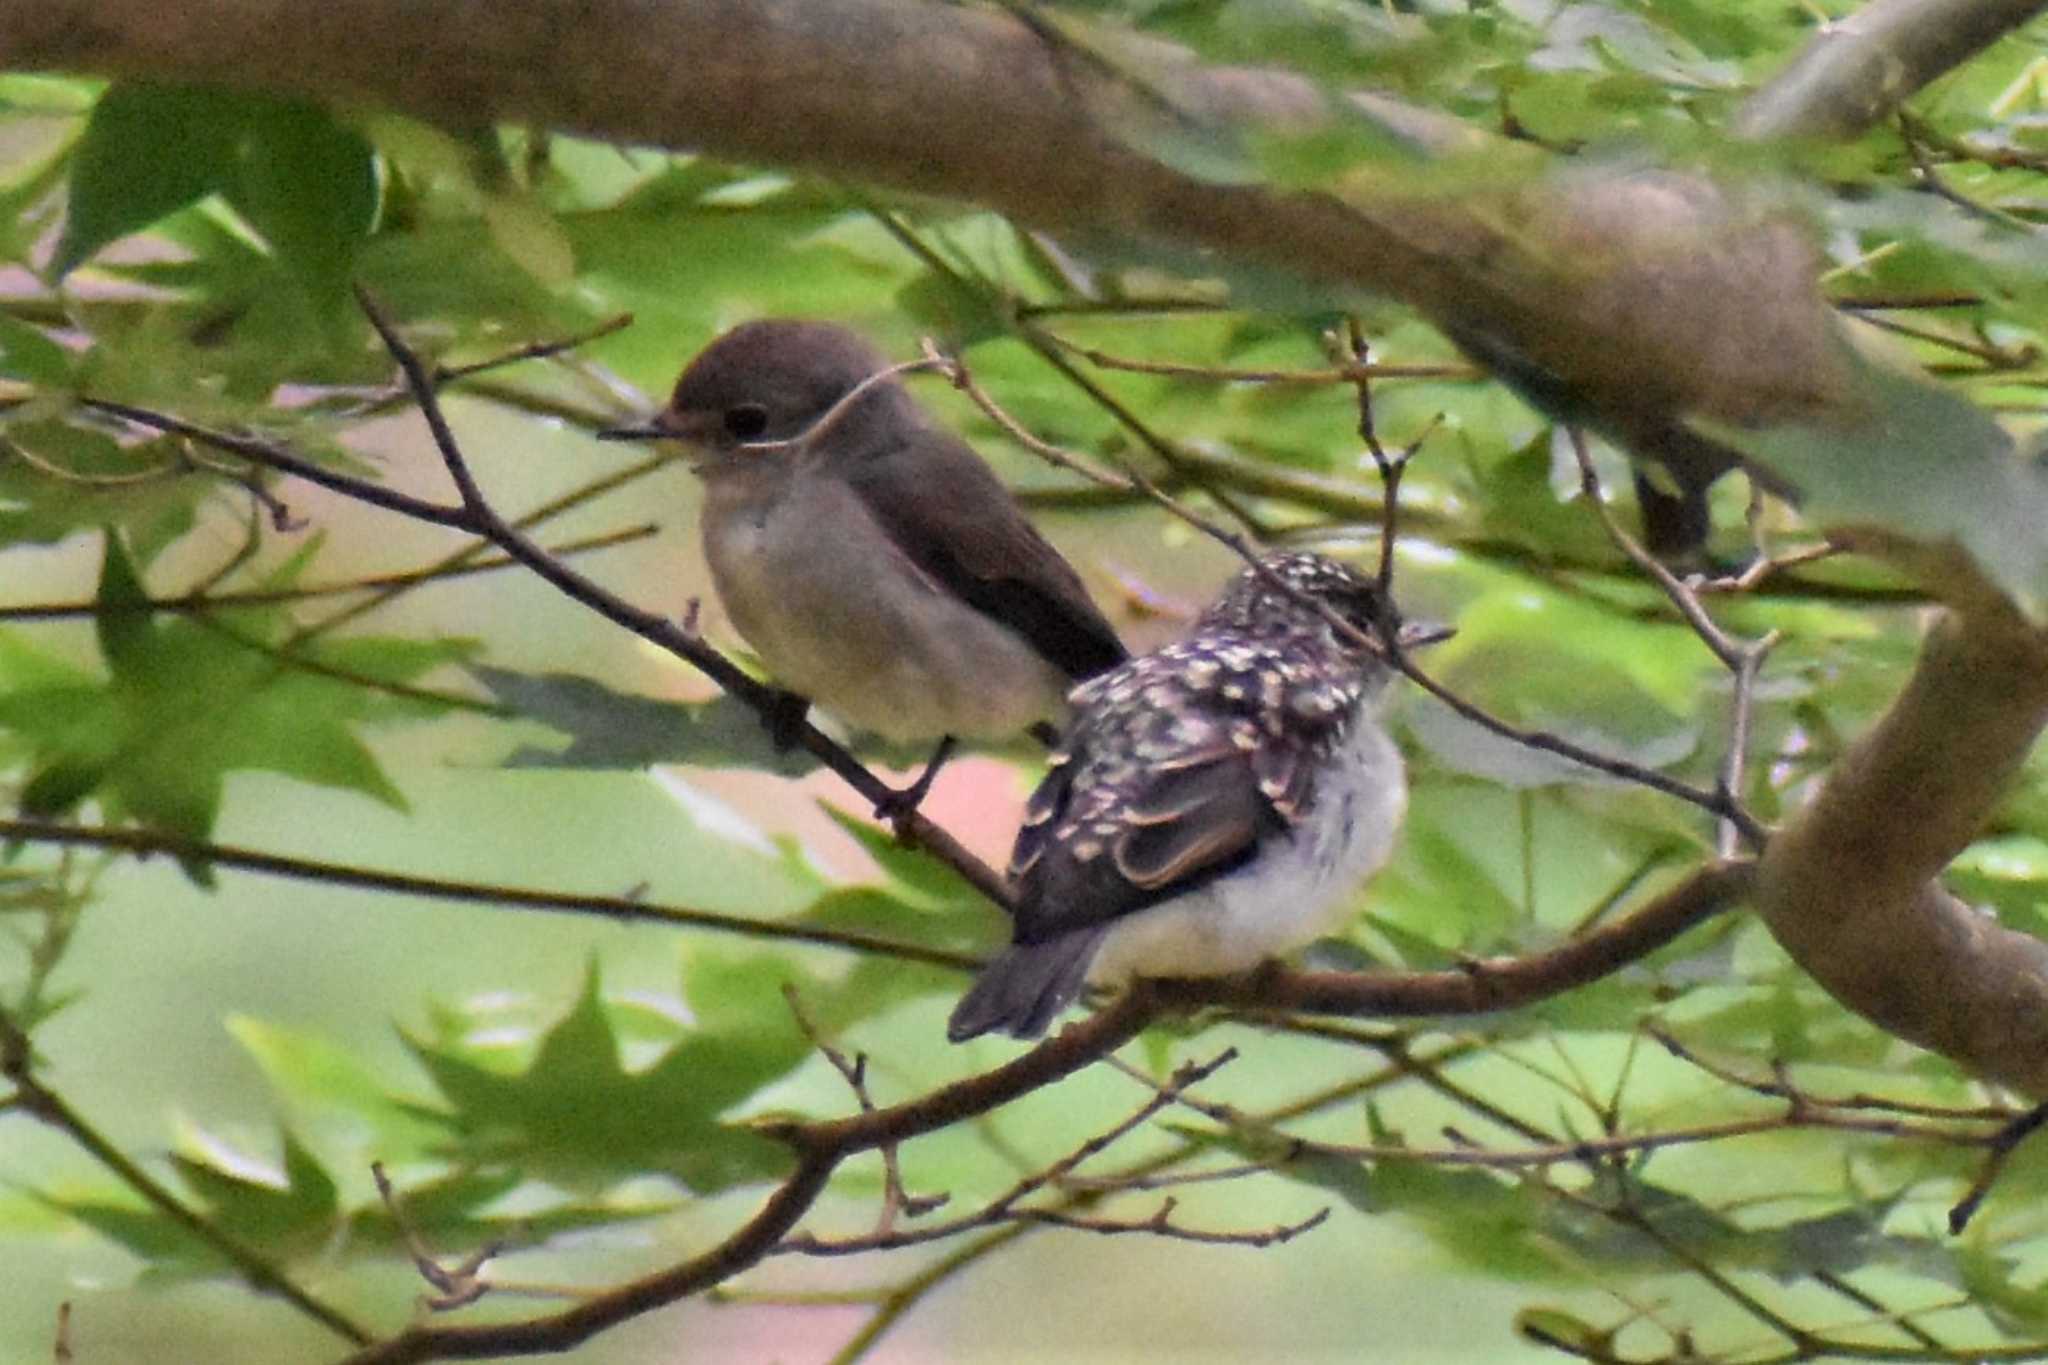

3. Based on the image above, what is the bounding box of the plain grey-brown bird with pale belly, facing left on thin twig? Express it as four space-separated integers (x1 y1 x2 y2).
602 319 1124 804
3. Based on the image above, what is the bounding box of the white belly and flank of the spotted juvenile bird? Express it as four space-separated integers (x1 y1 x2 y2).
1087 714 1407 986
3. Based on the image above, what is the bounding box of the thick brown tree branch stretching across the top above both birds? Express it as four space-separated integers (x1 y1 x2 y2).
0 0 1843 437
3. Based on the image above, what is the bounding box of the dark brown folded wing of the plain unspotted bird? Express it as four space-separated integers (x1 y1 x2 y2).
850 432 1124 679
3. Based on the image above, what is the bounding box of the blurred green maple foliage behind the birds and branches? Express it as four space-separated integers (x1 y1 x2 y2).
0 0 2048 1361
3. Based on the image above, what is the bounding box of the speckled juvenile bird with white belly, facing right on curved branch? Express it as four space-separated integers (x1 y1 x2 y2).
946 555 1446 1042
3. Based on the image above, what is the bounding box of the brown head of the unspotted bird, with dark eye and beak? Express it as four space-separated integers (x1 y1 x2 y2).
606 317 920 467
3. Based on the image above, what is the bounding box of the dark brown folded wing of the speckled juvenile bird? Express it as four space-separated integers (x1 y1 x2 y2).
1010 741 1307 943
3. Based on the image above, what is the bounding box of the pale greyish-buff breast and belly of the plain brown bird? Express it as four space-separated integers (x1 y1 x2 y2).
702 479 1069 741
